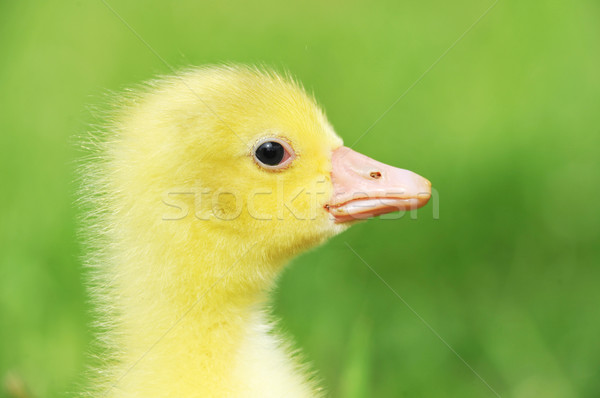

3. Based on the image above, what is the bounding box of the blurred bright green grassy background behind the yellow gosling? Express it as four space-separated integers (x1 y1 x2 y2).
0 0 600 398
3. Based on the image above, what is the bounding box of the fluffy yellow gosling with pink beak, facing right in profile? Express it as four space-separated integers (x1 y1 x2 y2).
84 66 430 398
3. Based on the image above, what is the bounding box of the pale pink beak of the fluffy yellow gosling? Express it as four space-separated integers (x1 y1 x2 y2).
325 146 431 223
